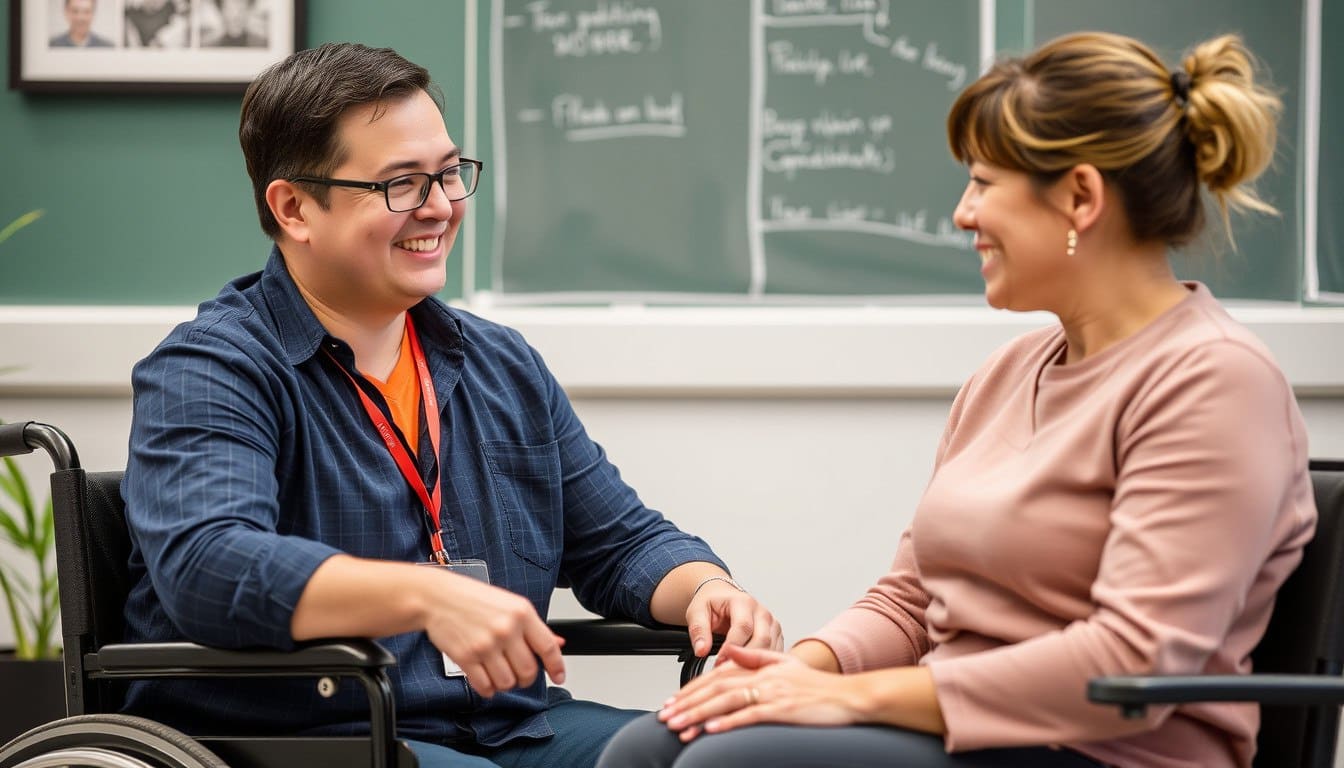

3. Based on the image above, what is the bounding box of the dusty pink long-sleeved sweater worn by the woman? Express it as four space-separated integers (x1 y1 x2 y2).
814 284 1316 768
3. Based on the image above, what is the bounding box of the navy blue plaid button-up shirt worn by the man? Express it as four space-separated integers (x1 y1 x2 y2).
122 249 722 745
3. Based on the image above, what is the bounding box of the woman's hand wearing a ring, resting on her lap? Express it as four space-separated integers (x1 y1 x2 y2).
659 646 863 741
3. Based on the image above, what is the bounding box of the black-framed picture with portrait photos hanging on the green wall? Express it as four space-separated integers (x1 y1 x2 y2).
9 0 305 93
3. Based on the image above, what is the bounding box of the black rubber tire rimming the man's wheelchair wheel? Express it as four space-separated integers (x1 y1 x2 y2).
0 714 228 768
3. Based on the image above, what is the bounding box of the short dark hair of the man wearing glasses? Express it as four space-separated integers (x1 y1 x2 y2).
238 43 442 239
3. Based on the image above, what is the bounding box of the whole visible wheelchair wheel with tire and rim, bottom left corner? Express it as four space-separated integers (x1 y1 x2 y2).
0 714 228 768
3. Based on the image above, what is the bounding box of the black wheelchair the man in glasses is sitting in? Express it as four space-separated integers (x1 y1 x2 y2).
0 421 722 768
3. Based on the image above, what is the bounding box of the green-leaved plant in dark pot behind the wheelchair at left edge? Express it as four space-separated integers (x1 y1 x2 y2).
0 211 66 744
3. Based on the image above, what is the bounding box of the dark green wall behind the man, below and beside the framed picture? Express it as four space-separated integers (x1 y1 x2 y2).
0 0 465 304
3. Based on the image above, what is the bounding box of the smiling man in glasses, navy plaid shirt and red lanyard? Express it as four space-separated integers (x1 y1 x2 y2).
122 44 781 767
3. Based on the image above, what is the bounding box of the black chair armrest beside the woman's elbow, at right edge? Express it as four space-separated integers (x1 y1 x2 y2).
1087 674 1344 717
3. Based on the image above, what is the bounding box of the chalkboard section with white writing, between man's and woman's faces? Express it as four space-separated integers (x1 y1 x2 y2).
489 0 980 301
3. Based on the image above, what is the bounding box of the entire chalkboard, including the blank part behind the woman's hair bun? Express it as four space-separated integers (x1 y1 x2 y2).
468 0 1344 304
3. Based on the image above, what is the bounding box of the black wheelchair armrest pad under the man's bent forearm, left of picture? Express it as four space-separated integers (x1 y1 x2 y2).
86 639 396 677
